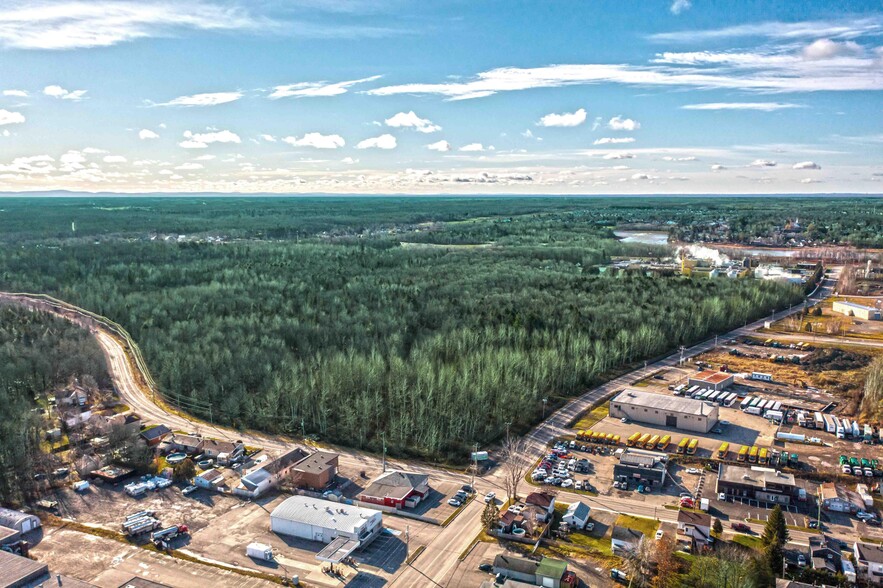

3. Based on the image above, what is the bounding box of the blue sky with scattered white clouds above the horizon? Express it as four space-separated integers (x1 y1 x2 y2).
0 0 883 194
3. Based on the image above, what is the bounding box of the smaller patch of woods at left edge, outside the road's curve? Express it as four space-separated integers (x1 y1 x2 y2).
0 305 110 503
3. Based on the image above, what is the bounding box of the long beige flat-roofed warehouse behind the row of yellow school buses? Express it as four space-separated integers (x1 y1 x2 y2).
610 388 718 433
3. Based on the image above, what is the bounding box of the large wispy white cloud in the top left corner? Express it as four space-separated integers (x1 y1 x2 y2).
0 0 262 50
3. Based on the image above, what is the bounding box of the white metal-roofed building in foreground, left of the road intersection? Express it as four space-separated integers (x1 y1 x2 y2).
270 496 383 547
